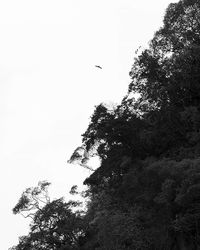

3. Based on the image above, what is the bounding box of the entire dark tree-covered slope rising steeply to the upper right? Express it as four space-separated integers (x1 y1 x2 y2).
12 0 200 250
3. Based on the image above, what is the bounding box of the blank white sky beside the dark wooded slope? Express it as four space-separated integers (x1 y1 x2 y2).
0 0 177 250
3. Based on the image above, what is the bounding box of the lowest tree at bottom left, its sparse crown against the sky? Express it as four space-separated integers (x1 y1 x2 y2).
13 182 84 250
